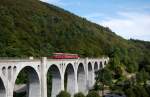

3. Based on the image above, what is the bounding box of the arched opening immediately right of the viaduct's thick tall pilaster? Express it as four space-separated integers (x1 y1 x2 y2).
47 65 61 97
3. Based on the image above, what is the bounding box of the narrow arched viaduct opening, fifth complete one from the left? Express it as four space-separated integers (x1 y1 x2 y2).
88 62 93 89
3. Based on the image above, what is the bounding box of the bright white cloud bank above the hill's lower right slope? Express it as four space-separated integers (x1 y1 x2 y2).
98 12 150 41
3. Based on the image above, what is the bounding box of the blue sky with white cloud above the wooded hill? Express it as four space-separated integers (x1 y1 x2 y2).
41 0 150 41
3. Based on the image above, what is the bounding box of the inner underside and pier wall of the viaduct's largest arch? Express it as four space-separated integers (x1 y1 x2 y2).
13 66 41 97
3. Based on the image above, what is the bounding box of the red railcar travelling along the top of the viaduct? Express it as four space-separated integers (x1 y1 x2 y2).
52 53 80 59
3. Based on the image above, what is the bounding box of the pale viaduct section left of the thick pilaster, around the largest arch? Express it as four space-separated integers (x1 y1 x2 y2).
0 59 41 97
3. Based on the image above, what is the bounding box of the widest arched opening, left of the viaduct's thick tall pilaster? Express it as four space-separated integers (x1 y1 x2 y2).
13 66 41 97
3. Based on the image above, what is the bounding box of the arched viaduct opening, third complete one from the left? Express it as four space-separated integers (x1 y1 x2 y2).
64 64 75 96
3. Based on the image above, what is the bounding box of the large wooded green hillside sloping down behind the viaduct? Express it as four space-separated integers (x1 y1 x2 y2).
0 0 150 69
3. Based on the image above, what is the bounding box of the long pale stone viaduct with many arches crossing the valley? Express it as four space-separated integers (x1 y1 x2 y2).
0 57 109 97
